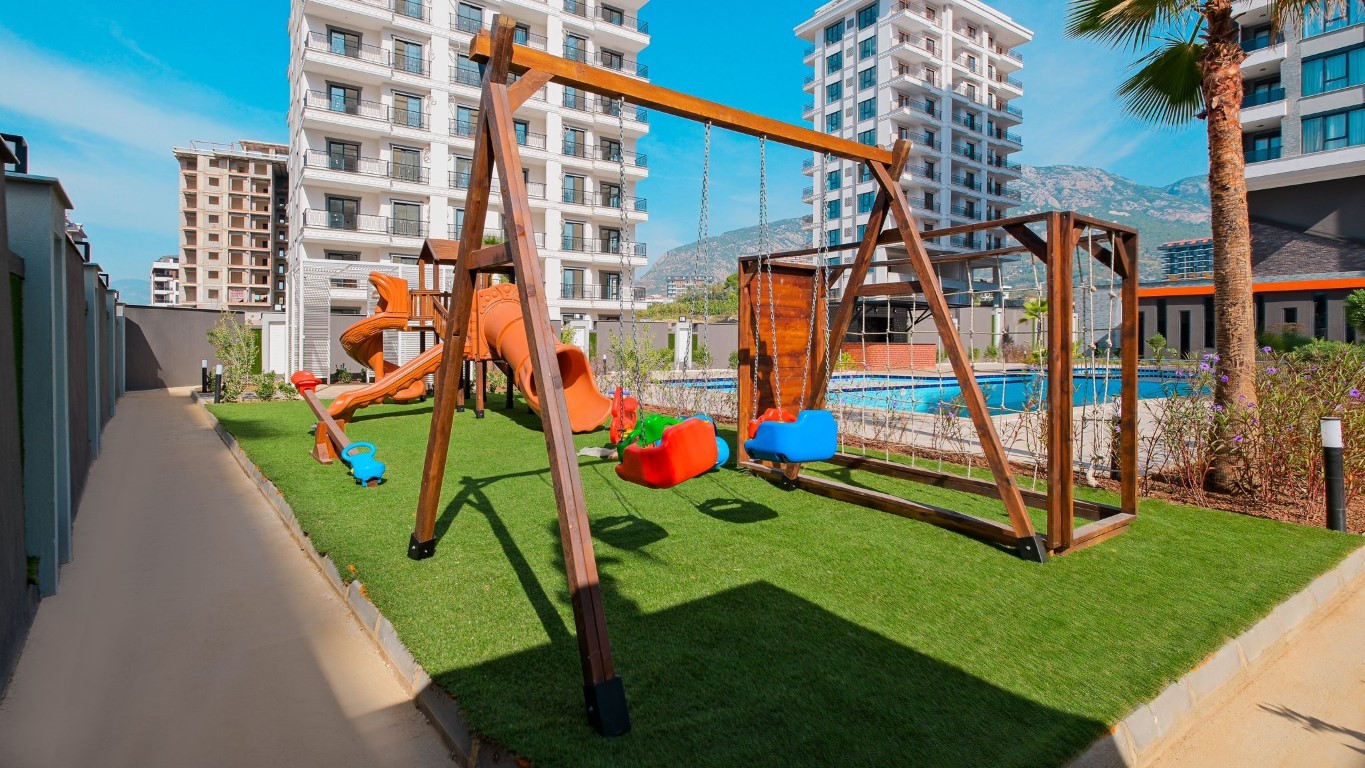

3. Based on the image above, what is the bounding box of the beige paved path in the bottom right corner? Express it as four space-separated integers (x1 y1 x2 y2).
1151 567 1365 768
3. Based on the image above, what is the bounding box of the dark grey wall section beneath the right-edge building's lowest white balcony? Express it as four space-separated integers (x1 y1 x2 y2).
1246 176 1365 241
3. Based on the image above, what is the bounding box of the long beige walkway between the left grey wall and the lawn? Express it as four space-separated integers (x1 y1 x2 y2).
0 392 452 768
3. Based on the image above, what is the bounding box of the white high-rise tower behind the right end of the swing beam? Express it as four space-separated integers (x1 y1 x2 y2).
796 0 1032 297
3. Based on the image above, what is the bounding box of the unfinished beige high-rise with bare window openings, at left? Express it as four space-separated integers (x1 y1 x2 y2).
175 141 289 311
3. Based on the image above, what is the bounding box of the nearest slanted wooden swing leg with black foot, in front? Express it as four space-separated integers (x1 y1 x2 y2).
479 73 631 735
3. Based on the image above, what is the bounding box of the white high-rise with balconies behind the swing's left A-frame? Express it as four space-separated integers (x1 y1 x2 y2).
288 0 650 370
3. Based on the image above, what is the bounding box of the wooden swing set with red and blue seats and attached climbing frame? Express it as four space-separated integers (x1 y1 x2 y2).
408 15 1138 735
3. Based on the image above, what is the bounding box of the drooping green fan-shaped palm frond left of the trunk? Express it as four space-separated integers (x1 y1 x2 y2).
1117 40 1204 124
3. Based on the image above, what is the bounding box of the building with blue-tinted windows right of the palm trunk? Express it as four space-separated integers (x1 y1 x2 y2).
1235 0 1365 243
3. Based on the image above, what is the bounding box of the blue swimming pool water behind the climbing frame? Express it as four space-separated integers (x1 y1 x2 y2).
684 370 1189 413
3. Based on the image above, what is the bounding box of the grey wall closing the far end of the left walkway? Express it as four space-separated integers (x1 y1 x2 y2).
124 306 242 392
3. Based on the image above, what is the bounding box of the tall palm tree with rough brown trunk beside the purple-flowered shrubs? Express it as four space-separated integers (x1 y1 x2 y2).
1066 0 1321 491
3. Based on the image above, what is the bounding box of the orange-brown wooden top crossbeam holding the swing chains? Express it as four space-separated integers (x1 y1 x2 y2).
470 30 891 165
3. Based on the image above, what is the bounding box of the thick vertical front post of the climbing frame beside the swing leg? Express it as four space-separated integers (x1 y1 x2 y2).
1046 213 1076 551
